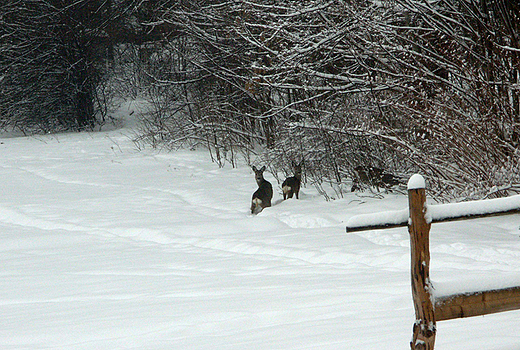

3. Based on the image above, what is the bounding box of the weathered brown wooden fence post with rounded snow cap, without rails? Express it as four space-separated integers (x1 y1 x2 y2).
408 174 436 350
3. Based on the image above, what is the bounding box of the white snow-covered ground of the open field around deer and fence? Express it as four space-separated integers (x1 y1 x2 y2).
0 108 520 350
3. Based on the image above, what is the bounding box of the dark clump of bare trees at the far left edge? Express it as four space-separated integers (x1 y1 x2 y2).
0 0 122 132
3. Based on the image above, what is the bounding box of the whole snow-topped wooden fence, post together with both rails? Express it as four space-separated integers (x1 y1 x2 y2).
347 175 520 350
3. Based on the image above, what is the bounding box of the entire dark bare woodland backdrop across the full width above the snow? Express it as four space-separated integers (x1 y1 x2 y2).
0 0 520 201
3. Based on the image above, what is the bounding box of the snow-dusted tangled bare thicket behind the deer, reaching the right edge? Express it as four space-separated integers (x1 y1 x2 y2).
133 0 520 199
